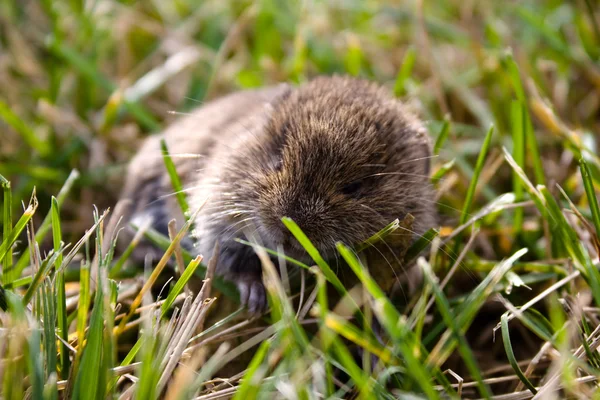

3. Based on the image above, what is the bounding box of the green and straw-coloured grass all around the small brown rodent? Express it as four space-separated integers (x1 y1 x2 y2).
0 0 600 399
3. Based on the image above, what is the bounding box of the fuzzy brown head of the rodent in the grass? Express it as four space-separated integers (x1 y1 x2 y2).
223 77 433 256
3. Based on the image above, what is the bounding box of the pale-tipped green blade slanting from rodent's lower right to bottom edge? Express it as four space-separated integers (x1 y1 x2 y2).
417 257 492 399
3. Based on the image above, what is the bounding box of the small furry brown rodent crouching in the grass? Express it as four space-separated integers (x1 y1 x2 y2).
122 76 435 312
